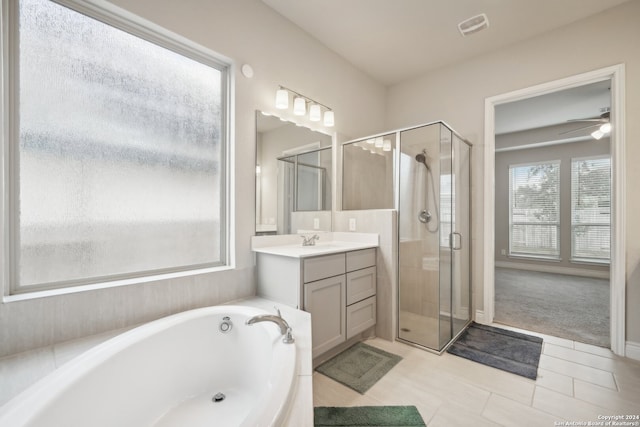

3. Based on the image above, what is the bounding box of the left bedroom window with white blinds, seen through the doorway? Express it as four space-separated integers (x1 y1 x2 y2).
509 160 560 259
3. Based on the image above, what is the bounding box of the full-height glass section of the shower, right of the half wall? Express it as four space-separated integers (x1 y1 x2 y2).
398 122 470 351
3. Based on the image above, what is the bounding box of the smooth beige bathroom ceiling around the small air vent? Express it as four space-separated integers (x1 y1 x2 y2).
262 0 627 85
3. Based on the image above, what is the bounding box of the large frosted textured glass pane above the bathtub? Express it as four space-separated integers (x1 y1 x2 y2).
11 0 227 292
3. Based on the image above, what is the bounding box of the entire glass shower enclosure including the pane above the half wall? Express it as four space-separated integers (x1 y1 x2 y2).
342 121 471 352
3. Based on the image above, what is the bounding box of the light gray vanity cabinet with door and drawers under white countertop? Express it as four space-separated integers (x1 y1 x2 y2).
257 248 376 357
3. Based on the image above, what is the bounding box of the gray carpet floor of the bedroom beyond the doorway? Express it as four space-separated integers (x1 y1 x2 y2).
494 268 611 348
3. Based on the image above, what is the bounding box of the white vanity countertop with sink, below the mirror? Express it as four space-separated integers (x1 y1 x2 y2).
251 232 379 258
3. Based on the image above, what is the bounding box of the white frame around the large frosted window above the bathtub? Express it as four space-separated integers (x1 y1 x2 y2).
0 0 235 302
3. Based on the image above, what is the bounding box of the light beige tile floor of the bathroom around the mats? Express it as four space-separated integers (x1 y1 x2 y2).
313 328 640 427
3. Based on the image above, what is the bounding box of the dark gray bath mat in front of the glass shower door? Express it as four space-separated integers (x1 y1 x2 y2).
447 322 542 380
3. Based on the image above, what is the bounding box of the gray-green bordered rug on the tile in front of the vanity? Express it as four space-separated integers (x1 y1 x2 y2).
316 343 402 394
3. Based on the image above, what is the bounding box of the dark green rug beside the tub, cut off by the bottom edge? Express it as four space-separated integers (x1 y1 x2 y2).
313 406 425 427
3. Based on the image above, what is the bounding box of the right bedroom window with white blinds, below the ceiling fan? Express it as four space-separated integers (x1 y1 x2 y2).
571 156 611 263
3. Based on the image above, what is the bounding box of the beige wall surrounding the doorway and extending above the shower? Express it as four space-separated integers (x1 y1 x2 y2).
387 0 640 342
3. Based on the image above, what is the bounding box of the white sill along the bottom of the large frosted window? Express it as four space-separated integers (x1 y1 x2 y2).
2 265 235 303
